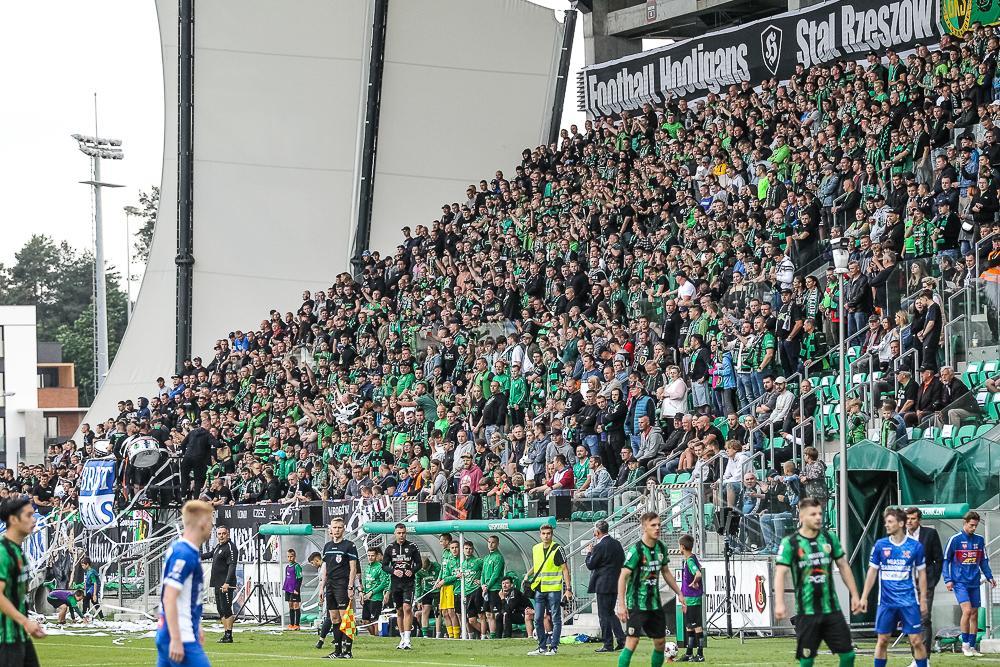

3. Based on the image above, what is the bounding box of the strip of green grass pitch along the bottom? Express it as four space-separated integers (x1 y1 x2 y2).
36 631 1000 667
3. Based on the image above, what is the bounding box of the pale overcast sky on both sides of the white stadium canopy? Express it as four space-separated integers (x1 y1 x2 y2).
0 0 583 295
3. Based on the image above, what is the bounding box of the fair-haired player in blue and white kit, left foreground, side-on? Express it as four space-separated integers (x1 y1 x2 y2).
156 500 215 667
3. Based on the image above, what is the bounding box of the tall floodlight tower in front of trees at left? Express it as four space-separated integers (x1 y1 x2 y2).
71 130 125 390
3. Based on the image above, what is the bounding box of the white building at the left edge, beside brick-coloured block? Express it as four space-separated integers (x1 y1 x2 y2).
0 306 45 468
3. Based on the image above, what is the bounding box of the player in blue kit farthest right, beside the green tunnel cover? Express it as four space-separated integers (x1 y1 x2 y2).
941 512 997 657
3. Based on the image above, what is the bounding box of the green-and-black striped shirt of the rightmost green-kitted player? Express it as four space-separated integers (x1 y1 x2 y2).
776 530 844 615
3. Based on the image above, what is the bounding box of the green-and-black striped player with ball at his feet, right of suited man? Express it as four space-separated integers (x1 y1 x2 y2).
617 512 685 667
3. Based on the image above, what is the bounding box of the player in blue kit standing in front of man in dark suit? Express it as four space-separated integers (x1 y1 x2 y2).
861 507 927 667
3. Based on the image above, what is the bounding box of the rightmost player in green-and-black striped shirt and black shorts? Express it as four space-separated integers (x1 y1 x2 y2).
774 498 860 667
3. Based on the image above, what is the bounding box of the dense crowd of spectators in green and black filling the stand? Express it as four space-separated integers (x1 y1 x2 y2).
0 25 1000 548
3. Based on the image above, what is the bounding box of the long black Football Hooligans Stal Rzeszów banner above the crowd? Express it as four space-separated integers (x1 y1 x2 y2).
578 0 1000 117
